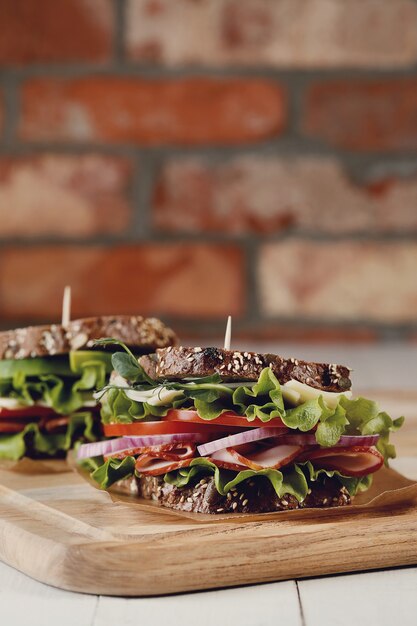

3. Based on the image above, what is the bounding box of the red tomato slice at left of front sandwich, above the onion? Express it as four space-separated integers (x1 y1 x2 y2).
103 420 242 437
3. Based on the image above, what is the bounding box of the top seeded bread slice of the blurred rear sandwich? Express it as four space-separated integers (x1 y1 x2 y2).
0 315 177 359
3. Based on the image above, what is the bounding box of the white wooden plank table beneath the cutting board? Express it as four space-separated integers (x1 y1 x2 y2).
0 345 417 626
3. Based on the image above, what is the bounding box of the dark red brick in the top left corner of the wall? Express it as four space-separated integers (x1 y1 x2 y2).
0 0 113 64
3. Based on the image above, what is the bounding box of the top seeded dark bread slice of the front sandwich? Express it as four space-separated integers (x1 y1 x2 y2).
139 346 351 392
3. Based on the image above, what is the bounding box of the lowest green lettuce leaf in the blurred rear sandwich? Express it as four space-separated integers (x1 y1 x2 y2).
0 412 98 461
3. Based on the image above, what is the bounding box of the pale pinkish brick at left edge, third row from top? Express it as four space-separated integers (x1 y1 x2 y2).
0 154 132 238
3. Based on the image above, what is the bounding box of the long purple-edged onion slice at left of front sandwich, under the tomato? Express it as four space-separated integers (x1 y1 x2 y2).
77 433 206 459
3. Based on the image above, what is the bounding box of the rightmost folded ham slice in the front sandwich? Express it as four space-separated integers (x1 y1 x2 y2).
303 447 384 476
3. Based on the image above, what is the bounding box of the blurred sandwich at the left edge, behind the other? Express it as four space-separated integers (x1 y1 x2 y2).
0 316 176 461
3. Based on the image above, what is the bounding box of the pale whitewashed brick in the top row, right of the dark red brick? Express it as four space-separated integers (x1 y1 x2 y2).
127 0 417 68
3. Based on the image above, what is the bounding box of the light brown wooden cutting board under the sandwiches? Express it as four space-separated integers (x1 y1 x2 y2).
0 394 417 596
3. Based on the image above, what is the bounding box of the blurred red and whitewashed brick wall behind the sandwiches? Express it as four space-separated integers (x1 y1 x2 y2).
0 0 417 340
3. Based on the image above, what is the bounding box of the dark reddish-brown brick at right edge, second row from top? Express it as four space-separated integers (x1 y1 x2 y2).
302 79 417 151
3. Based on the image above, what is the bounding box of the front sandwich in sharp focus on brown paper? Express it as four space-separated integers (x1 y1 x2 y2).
78 346 403 514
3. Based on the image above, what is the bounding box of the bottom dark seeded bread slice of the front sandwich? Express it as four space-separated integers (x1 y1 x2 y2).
113 476 351 514
